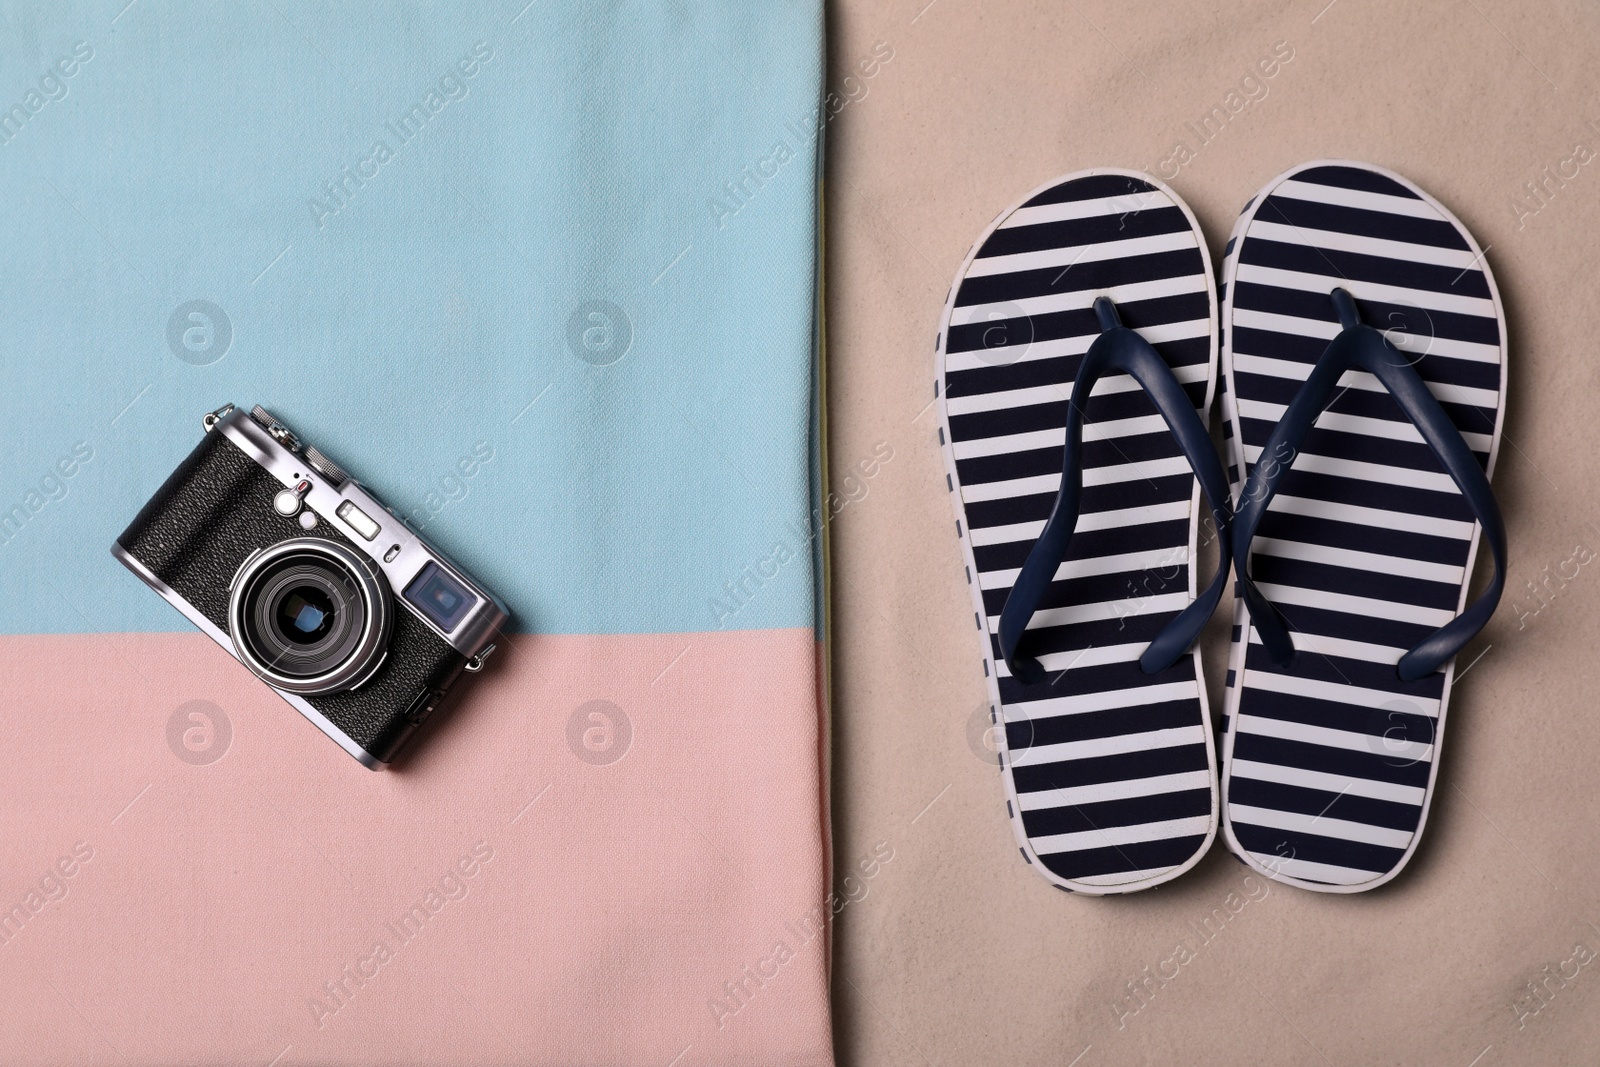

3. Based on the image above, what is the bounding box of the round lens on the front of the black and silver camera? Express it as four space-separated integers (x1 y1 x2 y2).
229 537 392 693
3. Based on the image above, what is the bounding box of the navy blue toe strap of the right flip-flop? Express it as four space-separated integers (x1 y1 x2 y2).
1234 290 1506 681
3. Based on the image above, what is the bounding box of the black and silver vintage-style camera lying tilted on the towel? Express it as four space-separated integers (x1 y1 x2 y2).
110 405 509 769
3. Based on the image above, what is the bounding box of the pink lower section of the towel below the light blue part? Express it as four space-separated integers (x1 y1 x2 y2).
0 629 834 1067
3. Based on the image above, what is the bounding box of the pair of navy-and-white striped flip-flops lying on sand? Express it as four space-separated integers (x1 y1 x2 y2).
936 162 1506 894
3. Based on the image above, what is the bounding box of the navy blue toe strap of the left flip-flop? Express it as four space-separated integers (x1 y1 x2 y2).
1000 296 1232 683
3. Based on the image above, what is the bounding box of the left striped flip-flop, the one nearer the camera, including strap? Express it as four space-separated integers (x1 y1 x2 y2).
934 170 1229 894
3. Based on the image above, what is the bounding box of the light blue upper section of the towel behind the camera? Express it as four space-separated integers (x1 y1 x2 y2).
0 0 822 633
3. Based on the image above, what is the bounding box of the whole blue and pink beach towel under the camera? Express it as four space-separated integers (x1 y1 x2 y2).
0 0 835 1067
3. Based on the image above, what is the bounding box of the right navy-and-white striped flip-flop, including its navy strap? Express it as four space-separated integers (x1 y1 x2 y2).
1222 162 1506 893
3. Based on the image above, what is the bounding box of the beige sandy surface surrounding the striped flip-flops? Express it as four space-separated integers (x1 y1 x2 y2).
827 0 1600 1067
